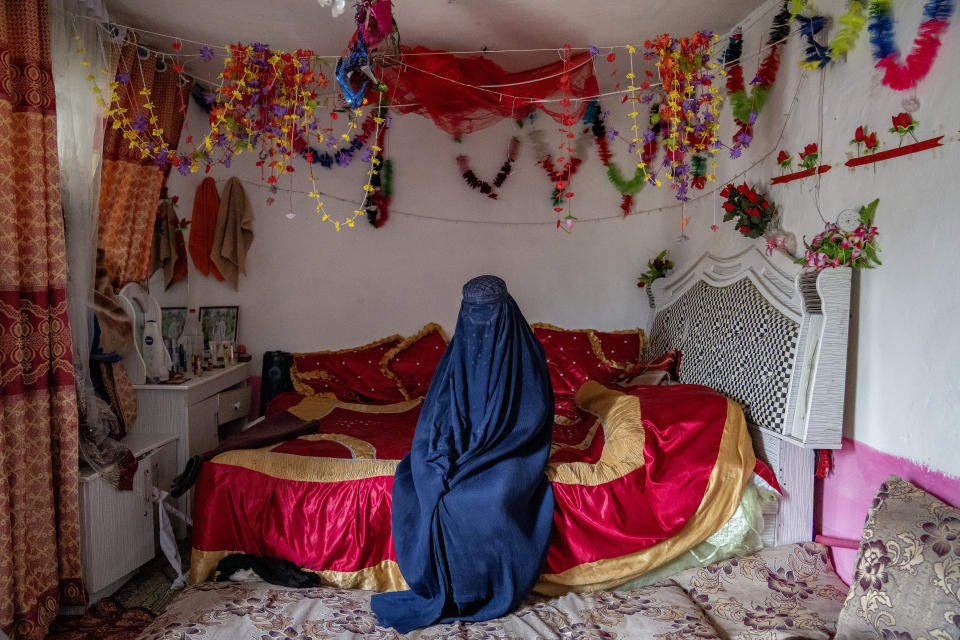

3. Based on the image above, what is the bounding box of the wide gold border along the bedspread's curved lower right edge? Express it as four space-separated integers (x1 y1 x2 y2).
534 390 756 595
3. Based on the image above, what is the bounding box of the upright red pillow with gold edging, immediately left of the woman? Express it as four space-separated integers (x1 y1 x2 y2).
380 322 447 400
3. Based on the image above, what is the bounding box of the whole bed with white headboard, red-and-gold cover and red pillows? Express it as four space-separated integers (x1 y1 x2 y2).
180 249 850 595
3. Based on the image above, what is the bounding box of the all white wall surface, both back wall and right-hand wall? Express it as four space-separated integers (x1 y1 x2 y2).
156 0 960 475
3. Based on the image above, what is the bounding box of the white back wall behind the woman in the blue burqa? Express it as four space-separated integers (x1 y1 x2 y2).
151 90 679 373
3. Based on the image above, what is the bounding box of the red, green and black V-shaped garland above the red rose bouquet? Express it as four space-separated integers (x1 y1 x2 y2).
723 0 790 152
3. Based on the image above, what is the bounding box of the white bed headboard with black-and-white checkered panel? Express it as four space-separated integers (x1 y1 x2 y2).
647 247 851 544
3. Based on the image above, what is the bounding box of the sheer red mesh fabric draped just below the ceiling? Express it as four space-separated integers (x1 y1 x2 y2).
384 47 597 137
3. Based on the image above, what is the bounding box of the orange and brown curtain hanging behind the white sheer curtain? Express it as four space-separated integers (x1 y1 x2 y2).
99 42 190 286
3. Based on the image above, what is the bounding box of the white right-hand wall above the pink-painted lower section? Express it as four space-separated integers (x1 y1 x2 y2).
676 0 960 475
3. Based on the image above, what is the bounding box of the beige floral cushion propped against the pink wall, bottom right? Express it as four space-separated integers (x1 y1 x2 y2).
836 476 960 640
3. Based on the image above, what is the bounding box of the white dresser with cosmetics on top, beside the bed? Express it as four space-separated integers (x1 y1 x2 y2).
133 362 250 536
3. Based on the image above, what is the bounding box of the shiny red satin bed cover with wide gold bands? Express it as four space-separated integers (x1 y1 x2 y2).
190 382 756 594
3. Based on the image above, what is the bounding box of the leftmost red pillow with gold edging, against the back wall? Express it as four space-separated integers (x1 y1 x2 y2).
290 335 405 403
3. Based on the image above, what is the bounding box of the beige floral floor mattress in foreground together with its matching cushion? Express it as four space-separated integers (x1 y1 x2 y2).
140 476 960 640
